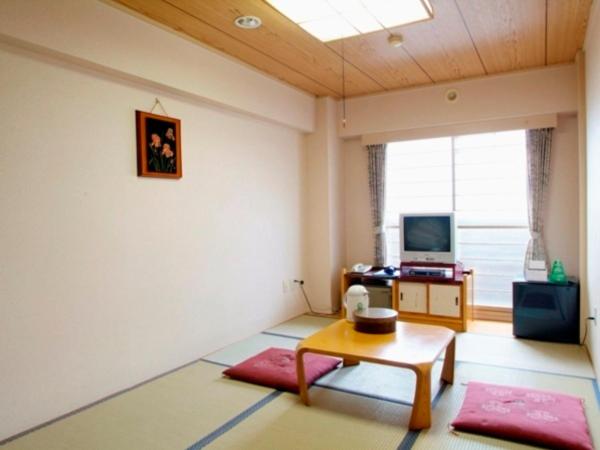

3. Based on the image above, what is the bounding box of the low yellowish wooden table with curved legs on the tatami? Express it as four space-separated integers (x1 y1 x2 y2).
296 319 455 430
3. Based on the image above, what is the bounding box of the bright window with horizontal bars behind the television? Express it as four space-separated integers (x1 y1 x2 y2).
385 130 529 307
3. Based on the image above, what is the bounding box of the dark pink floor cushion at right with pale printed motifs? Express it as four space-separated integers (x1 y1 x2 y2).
451 382 594 450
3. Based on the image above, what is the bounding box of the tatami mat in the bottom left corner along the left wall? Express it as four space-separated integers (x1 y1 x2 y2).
2 362 273 450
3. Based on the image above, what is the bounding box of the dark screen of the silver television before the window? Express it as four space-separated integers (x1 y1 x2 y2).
404 216 452 252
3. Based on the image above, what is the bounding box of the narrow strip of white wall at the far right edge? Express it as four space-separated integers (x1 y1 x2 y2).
584 2 600 375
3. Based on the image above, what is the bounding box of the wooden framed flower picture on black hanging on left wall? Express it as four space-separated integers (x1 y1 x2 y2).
135 111 182 178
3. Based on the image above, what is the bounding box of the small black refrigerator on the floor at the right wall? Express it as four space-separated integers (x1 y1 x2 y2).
513 279 579 343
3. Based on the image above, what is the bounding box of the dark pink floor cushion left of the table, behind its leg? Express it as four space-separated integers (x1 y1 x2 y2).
223 347 341 393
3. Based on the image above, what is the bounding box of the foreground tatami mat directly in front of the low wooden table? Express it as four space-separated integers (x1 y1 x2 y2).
206 387 411 450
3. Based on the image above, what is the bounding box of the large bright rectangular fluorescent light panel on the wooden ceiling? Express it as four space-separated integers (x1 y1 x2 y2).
266 0 433 42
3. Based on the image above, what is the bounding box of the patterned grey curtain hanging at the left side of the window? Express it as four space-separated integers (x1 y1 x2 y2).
367 144 386 266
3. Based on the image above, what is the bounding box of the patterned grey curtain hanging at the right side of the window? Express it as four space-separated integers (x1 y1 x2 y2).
525 128 553 267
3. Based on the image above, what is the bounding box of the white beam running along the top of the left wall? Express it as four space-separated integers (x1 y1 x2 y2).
0 0 315 132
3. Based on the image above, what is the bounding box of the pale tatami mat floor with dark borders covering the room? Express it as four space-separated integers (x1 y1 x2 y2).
2 315 600 450
